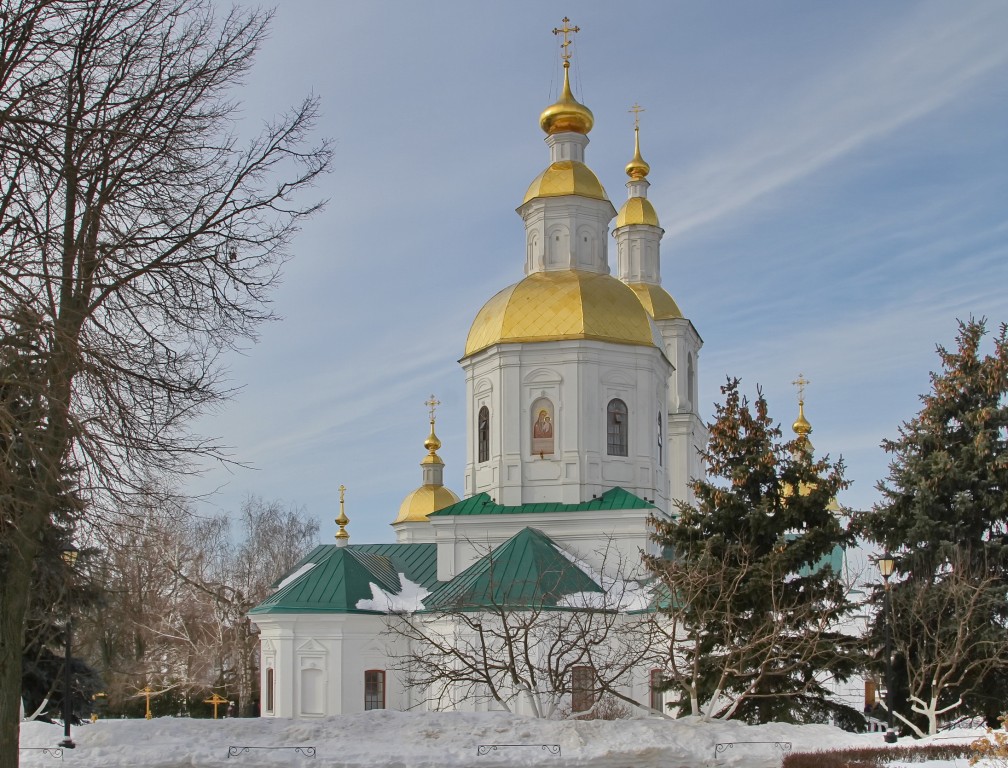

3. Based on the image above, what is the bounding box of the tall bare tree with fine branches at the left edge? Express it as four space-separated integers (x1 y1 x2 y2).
0 0 330 753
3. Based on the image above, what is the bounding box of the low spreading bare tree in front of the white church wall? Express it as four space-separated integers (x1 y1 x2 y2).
389 536 654 718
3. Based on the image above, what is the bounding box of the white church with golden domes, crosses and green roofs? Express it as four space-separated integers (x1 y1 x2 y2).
250 33 707 718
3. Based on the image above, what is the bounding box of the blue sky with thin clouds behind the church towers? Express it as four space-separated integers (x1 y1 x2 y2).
185 0 1008 543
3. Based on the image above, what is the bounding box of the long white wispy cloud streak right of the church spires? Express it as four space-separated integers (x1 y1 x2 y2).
666 3 1008 240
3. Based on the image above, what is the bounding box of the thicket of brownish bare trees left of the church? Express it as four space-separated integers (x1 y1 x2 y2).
80 487 319 717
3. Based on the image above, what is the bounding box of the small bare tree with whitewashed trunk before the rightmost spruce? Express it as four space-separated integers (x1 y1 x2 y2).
882 551 1008 736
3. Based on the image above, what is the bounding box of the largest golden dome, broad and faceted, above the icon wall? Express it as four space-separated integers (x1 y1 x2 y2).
464 269 662 357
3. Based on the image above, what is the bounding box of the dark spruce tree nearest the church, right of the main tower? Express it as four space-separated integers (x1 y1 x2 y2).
645 379 860 723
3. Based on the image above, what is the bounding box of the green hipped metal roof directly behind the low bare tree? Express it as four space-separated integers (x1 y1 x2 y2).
423 528 603 611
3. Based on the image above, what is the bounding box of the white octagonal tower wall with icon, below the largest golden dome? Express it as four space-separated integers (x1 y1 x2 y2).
462 340 671 511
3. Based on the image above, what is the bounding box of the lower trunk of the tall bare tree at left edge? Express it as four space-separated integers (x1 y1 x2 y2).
0 528 37 768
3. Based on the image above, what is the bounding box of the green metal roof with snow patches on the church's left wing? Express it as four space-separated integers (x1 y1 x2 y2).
249 544 437 614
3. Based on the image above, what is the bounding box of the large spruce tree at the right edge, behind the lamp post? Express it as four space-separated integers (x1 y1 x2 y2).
857 318 1008 722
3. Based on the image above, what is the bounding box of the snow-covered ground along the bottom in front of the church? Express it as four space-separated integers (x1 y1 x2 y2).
15 710 981 768
